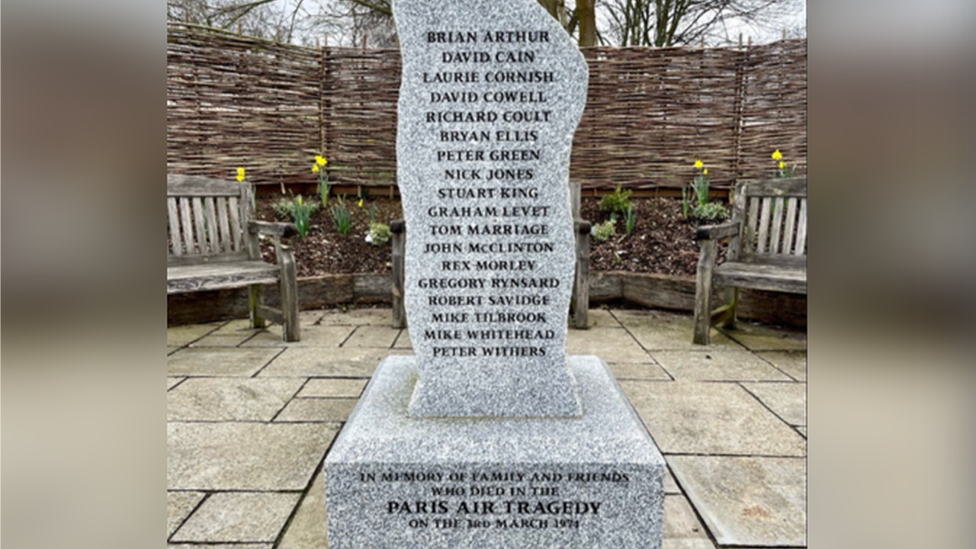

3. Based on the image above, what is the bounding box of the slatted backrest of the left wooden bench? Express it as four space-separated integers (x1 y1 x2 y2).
166 175 254 264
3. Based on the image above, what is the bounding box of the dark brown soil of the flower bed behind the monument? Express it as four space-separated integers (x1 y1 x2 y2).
257 197 716 277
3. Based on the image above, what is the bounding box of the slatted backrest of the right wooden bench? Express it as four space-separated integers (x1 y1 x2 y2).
729 177 807 261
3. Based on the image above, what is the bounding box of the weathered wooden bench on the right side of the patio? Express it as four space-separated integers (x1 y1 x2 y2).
693 177 807 345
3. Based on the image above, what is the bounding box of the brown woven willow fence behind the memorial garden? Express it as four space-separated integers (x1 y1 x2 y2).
166 24 807 195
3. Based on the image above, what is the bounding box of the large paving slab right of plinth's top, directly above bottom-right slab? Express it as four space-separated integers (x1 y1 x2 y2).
620 381 806 454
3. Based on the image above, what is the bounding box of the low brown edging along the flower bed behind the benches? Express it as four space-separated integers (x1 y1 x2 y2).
166 271 807 327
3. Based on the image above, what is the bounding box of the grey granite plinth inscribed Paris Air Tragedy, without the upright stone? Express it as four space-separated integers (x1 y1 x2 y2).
324 356 665 549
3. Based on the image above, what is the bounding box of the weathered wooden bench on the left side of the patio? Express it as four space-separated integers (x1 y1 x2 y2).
166 175 301 341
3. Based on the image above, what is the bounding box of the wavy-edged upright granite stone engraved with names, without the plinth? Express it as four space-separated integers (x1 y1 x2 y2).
393 0 588 417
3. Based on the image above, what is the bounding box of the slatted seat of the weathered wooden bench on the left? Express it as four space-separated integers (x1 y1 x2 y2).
166 261 279 294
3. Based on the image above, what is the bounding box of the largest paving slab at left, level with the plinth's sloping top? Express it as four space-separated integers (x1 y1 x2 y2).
166 422 338 490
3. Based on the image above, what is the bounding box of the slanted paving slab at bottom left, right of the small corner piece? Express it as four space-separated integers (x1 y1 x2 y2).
171 492 301 543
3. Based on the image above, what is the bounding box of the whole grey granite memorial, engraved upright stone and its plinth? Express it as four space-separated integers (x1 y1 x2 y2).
325 0 665 549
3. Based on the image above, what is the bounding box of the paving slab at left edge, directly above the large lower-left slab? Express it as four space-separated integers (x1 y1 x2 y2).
166 378 304 421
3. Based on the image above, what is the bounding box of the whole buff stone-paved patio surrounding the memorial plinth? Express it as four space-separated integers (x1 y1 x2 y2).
166 309 807 549
